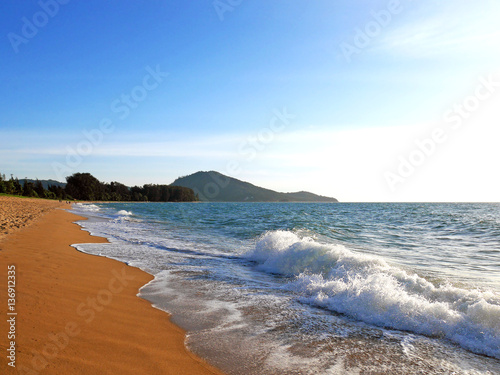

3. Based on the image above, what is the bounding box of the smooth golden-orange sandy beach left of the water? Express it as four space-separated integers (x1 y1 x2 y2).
0 197 221 375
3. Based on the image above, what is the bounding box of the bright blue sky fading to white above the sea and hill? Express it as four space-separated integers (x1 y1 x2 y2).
0 0 500 201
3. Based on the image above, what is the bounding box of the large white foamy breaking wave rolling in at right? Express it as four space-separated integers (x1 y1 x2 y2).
246 231 500 358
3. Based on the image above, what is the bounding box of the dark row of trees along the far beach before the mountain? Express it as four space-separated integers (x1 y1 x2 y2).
0 173 199 202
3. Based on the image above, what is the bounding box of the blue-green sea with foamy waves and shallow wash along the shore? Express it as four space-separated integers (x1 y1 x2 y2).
73 203 500 374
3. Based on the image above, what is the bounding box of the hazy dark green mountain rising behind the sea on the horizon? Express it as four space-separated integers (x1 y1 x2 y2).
171 171 338 203
